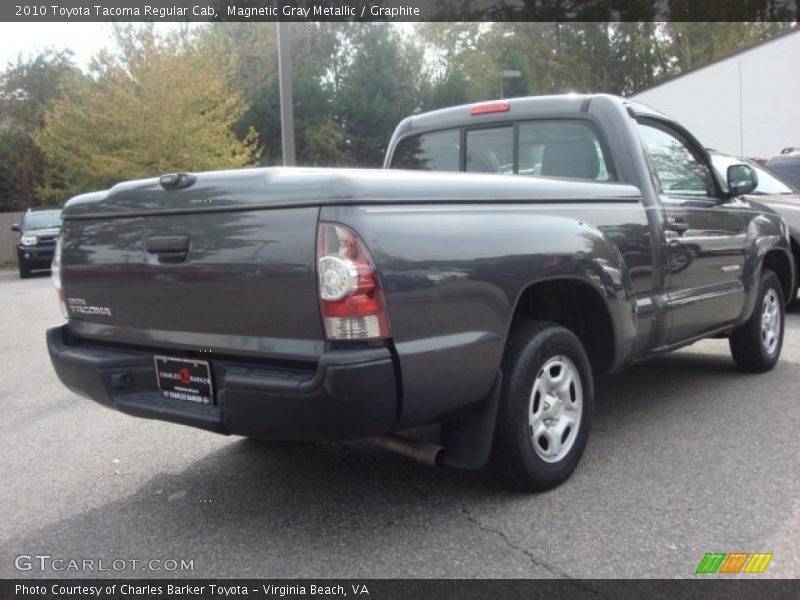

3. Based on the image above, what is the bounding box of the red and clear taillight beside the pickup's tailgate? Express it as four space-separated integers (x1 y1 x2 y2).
317 223 389 340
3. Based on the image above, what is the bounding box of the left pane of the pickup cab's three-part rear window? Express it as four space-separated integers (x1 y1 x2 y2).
392 129 461 171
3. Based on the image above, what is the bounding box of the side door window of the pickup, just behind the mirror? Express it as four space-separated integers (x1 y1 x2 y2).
639 123 714 197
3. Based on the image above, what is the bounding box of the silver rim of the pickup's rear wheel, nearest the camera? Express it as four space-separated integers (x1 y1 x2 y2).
528 356 583 463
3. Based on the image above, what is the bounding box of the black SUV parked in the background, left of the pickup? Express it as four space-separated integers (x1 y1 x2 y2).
11 206 61 279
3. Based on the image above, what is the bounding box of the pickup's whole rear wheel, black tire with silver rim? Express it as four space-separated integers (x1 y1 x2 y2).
493 321 594 491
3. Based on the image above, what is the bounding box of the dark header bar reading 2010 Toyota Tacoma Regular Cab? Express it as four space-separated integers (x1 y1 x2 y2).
0 0 800 22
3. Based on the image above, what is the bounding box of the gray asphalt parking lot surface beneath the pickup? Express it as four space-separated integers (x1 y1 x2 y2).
0 272 800 578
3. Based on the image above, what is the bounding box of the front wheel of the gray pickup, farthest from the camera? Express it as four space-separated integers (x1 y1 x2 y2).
729 269 786 373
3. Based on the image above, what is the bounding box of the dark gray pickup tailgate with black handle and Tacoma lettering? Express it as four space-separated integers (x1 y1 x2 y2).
62 185 324 362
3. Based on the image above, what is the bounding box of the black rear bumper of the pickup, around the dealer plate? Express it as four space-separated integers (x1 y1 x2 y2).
47 325 397 441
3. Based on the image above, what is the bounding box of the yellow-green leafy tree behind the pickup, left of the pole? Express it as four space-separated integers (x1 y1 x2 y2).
34 26 258 199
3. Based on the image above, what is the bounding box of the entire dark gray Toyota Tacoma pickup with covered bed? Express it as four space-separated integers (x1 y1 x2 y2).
47 95 794 490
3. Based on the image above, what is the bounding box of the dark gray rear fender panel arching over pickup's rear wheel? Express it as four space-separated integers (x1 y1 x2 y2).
320 203 644 427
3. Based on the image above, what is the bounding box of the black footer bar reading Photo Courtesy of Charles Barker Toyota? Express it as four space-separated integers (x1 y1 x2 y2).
0 576 800 600
